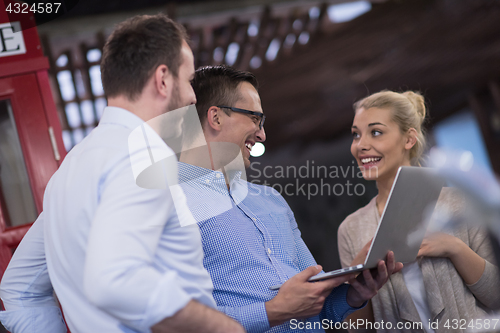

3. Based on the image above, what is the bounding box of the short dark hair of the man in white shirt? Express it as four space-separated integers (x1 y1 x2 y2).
101 14 187 100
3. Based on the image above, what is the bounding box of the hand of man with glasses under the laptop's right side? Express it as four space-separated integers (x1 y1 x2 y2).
347 251 403 308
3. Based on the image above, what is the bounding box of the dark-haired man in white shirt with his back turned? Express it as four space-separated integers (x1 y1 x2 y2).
0 15 243 333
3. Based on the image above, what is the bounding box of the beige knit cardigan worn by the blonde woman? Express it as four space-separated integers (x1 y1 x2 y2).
338 188 500 332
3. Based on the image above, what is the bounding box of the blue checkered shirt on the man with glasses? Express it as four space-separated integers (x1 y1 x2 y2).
179 163 357 332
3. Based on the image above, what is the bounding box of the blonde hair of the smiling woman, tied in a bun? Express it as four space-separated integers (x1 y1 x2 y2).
353 90 426 165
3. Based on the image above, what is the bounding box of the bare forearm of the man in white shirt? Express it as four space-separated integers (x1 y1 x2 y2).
151 300 245 333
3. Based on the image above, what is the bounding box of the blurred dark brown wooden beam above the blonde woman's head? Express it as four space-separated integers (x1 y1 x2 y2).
255 0 500 148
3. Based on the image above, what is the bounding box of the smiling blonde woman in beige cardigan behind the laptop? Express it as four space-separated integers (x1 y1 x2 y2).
338 91 500 332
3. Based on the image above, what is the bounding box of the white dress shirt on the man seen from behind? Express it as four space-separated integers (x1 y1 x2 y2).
1 107 215 333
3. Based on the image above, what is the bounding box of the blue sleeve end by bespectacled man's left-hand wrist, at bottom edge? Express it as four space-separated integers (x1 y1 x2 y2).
217 303 270 333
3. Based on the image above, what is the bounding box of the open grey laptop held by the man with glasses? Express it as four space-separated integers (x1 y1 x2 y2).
269 166 445 290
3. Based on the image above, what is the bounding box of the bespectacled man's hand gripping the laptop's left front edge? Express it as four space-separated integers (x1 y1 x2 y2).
266 265 356 327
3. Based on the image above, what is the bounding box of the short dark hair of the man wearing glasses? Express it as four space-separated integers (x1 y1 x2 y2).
192 65 259 124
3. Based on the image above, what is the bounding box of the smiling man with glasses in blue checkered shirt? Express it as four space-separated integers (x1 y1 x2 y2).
179 66 400 332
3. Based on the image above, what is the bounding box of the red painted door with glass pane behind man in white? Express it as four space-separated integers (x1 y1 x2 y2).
0 73 61 278
